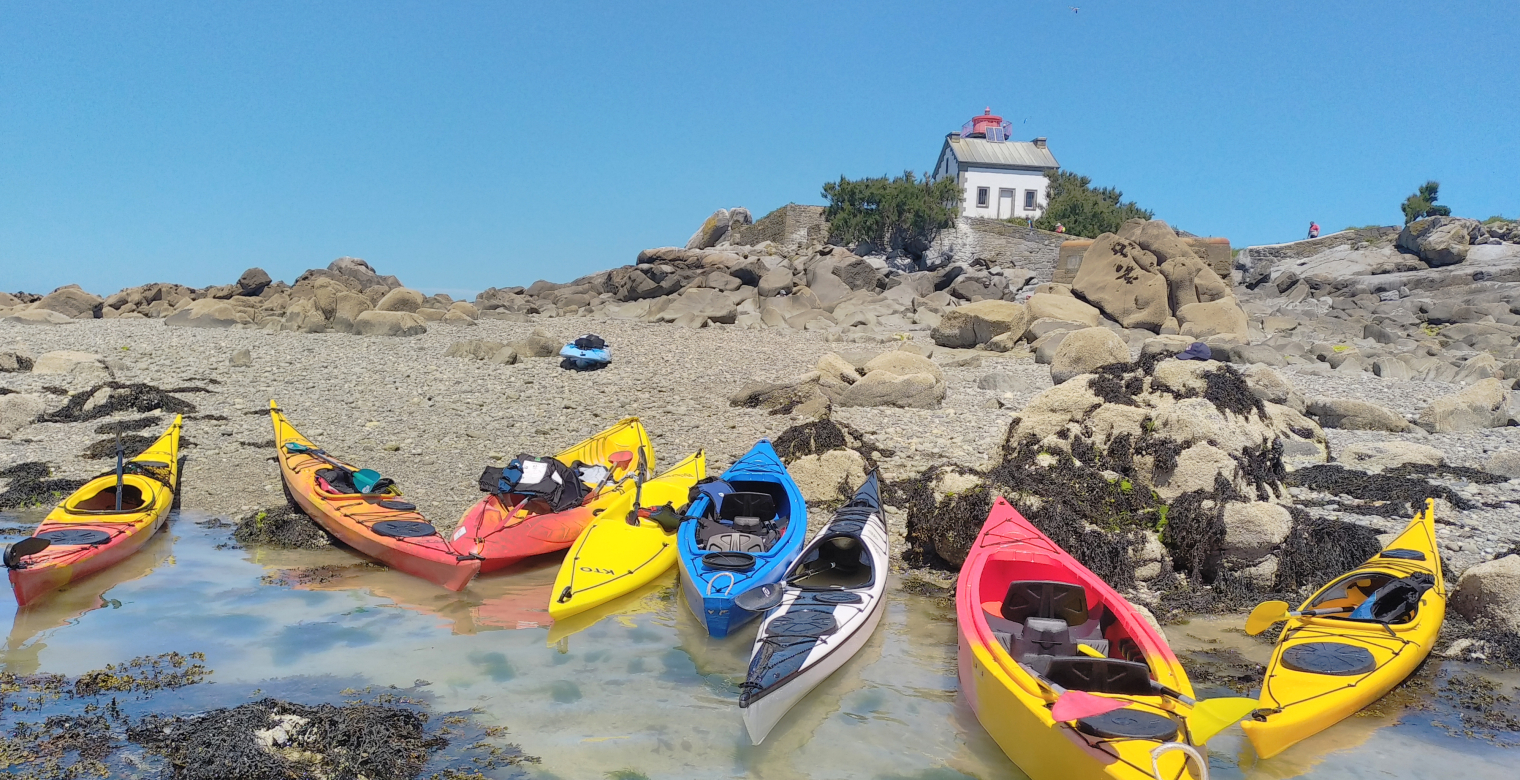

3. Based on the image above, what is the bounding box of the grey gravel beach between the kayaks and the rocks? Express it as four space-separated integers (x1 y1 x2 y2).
0 318 1520 570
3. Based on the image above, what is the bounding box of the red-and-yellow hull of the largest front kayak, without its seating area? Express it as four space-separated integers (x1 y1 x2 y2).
956 497 1201 780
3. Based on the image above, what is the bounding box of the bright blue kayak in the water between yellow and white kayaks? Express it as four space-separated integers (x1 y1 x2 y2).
676 439 807 637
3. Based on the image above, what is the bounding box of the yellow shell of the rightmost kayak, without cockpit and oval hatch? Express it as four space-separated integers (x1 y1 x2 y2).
1240 502 1447 759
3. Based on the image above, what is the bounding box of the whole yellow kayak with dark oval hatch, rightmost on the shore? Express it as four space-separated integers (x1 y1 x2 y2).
1240 502 1447 759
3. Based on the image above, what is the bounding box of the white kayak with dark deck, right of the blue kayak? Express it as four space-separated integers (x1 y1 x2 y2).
736 473 886 745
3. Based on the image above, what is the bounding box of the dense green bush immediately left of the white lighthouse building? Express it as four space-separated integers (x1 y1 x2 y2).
824 170 961 249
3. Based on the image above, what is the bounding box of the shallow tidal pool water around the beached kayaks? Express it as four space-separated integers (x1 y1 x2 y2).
0 512 1520 780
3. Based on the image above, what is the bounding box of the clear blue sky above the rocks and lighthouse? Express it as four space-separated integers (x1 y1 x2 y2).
0 0 1520 295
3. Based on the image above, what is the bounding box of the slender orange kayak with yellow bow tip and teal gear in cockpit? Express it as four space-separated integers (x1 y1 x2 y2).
269 401 480 590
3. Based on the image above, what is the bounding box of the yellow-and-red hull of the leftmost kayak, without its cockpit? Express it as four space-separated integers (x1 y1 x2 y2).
9 415 182 607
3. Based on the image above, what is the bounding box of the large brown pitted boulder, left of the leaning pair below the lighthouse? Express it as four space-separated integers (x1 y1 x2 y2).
1072 233 1172 331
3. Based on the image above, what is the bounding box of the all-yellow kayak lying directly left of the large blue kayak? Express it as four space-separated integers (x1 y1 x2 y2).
549 450 707 620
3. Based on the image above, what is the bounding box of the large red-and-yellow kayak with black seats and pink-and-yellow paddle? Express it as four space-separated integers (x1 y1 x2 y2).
956 499 1216 780
